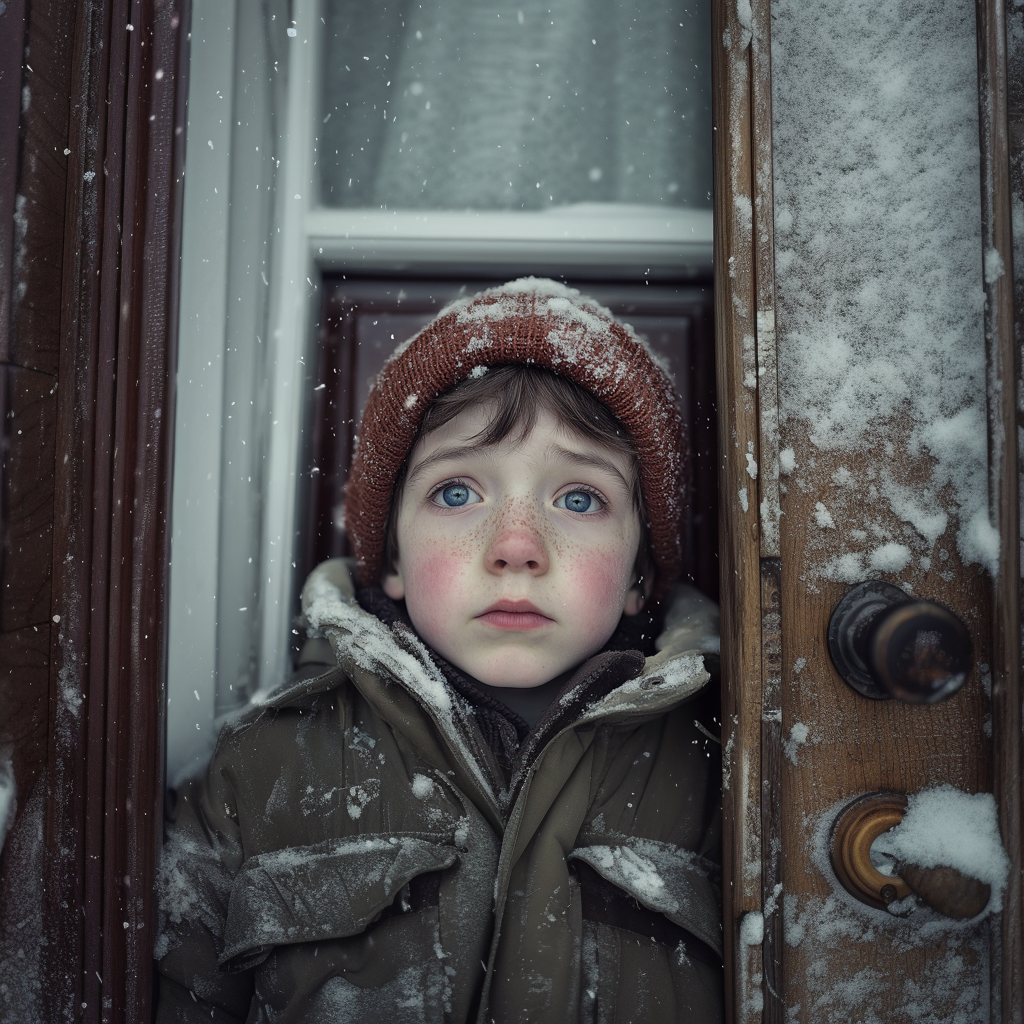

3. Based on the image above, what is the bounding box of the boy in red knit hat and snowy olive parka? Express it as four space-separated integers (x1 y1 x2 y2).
157 279 722 1024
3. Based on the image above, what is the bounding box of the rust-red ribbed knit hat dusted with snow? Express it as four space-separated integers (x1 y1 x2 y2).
345 278 686 601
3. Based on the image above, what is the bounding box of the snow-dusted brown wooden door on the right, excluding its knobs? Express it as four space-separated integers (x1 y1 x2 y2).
714 0 1022 1024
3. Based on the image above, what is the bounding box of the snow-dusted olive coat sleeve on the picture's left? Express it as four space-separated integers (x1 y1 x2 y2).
155 770 260 1024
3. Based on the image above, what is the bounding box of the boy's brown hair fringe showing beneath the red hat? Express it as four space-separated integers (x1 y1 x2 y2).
383 364 651 580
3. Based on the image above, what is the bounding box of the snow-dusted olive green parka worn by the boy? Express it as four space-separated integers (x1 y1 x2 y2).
157 561 723 1024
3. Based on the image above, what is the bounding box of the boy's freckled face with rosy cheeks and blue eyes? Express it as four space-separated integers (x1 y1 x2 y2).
383 407 643 687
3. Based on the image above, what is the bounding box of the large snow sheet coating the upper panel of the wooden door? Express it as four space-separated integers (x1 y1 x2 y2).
772 0 991 582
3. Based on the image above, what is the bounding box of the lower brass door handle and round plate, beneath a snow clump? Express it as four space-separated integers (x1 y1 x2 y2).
828 793 991 921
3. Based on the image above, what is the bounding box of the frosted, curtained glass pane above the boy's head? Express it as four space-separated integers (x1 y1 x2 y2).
318 0 712 210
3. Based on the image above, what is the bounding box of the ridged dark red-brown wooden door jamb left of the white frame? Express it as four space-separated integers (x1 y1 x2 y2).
46 0 185 1021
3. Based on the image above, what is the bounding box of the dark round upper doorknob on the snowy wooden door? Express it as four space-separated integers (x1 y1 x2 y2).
828 581 974 703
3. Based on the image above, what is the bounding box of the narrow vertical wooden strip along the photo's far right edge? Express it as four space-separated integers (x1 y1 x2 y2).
977 0 1024 1024
